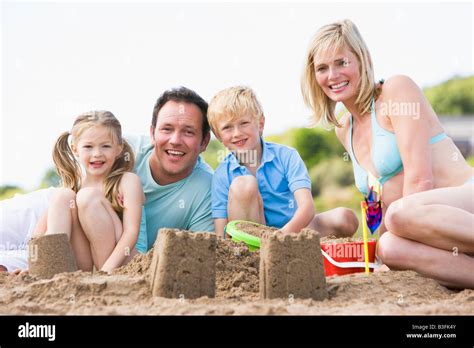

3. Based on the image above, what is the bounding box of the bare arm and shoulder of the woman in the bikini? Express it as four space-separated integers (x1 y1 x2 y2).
382 76 436 197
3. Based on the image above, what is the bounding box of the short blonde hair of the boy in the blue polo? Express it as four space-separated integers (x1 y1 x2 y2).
207 86 263 136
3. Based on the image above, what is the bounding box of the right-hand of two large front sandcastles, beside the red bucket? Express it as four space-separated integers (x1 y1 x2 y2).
260 229 327 300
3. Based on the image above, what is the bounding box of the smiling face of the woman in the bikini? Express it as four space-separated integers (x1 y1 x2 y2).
314 48 360 102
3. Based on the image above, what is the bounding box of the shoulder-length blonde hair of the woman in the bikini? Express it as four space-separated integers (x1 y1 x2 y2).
301 19 378 127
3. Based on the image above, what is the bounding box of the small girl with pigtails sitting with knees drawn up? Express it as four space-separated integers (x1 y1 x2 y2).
34 111 145 272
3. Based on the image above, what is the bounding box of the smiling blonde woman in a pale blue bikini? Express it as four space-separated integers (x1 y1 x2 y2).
301 20 474 288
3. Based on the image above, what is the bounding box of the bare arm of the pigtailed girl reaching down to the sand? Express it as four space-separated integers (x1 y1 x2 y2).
101 173 145 272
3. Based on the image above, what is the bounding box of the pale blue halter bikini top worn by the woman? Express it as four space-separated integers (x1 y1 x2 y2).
349 99 447 195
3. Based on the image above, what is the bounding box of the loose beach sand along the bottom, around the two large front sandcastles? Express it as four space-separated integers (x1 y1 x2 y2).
0 240 474 315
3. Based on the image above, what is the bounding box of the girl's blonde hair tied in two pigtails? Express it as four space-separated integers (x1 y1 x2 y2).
53 111 135 216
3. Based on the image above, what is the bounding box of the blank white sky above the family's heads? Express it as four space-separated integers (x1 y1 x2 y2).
0 1 474 189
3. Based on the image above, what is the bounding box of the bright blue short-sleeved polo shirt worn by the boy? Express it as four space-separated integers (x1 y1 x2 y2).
212 140 311 228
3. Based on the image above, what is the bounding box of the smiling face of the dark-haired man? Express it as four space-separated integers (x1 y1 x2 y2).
150 100 210 185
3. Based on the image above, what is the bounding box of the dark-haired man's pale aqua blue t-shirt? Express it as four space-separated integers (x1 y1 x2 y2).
126 136 214 253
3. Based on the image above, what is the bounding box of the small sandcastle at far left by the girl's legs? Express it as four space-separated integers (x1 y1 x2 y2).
28 233 77 278
